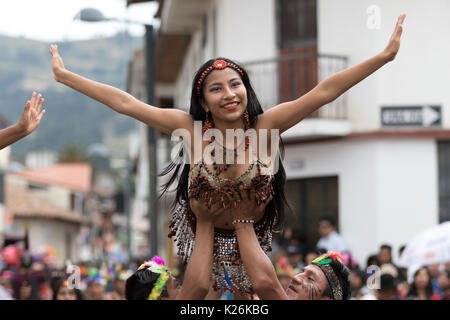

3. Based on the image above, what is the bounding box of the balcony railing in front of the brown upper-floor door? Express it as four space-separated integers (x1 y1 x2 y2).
244 53 347 119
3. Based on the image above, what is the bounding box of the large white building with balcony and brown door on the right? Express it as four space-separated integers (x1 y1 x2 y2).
128 0 450 266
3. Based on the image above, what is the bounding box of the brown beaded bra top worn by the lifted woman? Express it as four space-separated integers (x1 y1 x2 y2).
189 159 273 207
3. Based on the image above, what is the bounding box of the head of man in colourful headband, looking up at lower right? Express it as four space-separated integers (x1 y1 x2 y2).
286 251 351 300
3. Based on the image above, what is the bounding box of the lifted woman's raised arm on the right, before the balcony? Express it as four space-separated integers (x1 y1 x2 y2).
260 13 406 133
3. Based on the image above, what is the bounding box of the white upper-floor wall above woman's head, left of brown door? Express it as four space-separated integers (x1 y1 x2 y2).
174 0 278 111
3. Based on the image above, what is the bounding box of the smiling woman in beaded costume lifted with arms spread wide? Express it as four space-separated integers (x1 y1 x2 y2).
50 13 406 292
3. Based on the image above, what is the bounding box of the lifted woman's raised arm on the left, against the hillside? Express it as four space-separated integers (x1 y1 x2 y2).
50 45 193 134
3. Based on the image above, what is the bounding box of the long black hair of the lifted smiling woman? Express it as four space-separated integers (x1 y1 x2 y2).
160 57 289 228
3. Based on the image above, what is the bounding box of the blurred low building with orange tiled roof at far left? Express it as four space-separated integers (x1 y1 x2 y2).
4 163 92 263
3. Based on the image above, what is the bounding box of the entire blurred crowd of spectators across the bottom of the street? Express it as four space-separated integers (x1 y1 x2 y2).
0 218 450 300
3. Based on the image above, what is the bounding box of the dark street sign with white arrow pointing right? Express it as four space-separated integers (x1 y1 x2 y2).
381 105 442 127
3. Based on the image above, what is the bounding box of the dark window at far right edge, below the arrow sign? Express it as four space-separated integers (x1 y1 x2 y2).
438 141 450 223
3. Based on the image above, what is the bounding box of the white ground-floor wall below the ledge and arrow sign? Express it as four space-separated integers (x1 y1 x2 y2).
284 139 438 266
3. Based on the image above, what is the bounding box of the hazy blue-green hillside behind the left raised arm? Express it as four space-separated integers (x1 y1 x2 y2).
0 34 143 159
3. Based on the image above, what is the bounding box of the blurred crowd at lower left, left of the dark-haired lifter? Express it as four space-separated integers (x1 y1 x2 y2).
0 242 135 300
